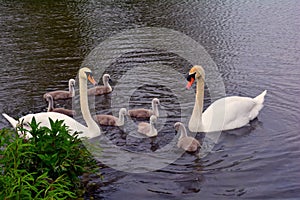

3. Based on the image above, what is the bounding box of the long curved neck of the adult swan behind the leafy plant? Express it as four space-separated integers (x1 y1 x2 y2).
79 75 101 138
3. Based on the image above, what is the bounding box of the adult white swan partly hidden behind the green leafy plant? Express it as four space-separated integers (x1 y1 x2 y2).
2 67 101 138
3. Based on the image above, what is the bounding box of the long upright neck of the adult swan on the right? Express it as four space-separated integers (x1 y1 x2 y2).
189 78 204 132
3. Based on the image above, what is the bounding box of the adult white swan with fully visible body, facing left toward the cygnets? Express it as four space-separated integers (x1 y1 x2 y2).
187 65 267 132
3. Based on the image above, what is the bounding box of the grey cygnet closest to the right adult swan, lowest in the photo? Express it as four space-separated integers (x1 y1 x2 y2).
174 122 200 152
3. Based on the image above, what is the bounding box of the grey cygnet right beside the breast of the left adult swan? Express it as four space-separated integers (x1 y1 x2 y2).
94 108 127 126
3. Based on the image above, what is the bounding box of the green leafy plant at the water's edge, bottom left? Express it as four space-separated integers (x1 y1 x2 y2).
0 118 98 199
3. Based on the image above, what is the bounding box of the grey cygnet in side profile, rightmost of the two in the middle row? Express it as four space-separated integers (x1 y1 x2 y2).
128 98 160 118
